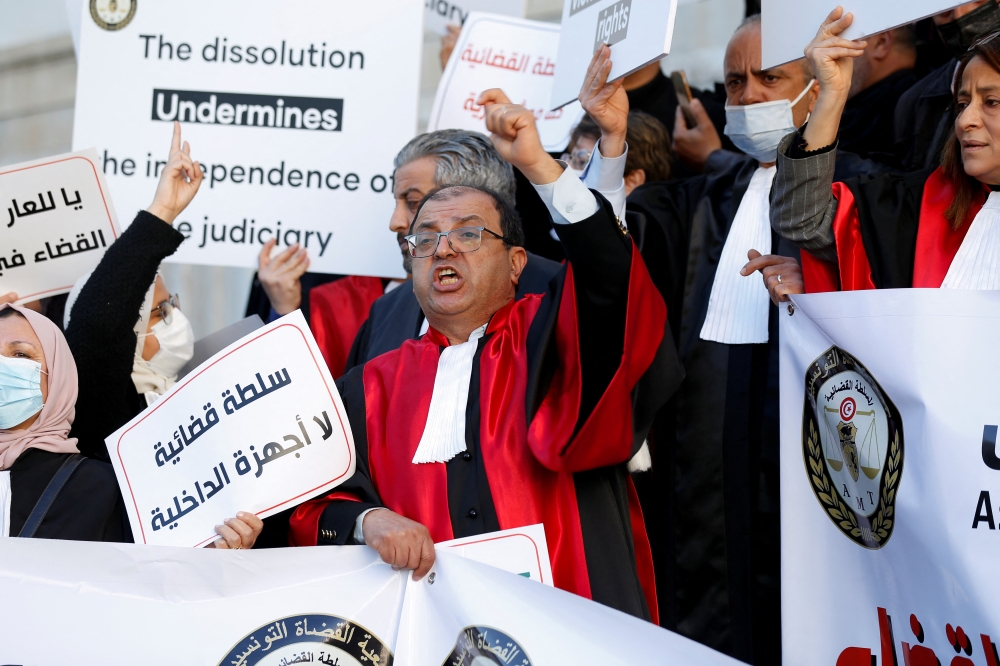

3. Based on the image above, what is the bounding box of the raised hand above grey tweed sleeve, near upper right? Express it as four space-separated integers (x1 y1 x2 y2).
804 7 868 150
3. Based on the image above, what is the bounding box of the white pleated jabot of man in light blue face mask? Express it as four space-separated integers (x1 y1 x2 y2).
701 167 777 345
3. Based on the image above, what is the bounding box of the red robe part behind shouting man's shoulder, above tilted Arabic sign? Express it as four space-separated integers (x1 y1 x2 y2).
309 275 385 377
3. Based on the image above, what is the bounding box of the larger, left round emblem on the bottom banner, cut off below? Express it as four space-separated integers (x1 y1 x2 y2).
219 614 393 666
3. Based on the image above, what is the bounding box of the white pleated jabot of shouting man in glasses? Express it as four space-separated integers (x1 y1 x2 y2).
413 324 487 465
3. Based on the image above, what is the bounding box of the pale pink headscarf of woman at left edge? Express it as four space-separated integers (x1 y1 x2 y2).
0 304 80 470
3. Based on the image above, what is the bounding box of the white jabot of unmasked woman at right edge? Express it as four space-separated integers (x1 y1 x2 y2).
941 192 1000 290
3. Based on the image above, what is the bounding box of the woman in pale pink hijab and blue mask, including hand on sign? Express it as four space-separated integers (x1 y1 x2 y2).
0 304 263 548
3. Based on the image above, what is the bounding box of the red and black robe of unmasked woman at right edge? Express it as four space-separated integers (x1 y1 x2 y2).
802 168 989 293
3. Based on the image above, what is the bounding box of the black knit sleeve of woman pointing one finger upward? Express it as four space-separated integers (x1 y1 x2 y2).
66 211 184 461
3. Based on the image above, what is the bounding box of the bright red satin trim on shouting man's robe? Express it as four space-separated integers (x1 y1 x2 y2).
364 243 666 598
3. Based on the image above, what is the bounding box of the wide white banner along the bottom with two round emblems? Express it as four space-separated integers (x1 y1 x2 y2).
0 539 744 666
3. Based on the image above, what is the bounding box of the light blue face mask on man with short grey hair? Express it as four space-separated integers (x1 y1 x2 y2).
726 79 816 164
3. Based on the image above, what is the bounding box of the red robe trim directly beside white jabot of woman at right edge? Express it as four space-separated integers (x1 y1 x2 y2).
913 168 986 289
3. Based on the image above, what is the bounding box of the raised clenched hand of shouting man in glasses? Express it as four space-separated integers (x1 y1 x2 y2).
476 88 562 185
